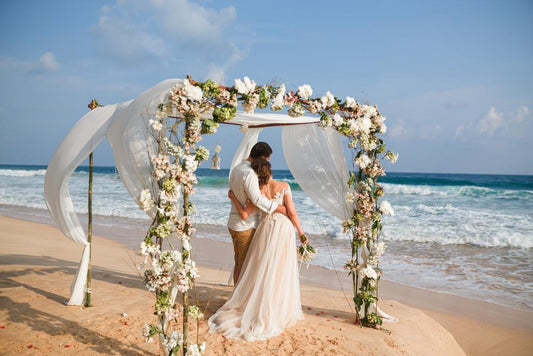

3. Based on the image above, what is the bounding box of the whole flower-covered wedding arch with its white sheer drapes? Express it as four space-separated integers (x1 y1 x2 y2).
45 77 397 354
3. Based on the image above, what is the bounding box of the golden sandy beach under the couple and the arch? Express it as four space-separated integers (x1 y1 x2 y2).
0 216 533 355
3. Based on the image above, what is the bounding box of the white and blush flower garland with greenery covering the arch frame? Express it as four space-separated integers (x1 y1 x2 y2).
138 77 398 355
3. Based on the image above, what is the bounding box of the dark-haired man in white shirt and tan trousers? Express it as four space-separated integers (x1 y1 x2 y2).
228 142 287 284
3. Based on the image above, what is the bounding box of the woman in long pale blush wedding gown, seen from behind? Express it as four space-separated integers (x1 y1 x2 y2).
208 158 305 340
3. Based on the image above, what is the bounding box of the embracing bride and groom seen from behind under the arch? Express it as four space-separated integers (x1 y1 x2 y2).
209 142 304 340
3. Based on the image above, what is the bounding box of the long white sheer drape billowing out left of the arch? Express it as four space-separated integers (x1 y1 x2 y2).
44 79 182 305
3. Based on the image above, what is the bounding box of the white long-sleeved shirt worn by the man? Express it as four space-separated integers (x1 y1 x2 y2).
228 160 278 231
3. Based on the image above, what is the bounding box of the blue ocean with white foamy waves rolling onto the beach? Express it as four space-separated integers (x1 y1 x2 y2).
0 165 533 310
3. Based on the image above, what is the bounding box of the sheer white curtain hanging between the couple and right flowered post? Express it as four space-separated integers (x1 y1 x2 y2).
282 124 353 220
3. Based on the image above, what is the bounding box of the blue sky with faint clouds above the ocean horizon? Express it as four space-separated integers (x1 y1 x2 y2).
0 0 533 174
